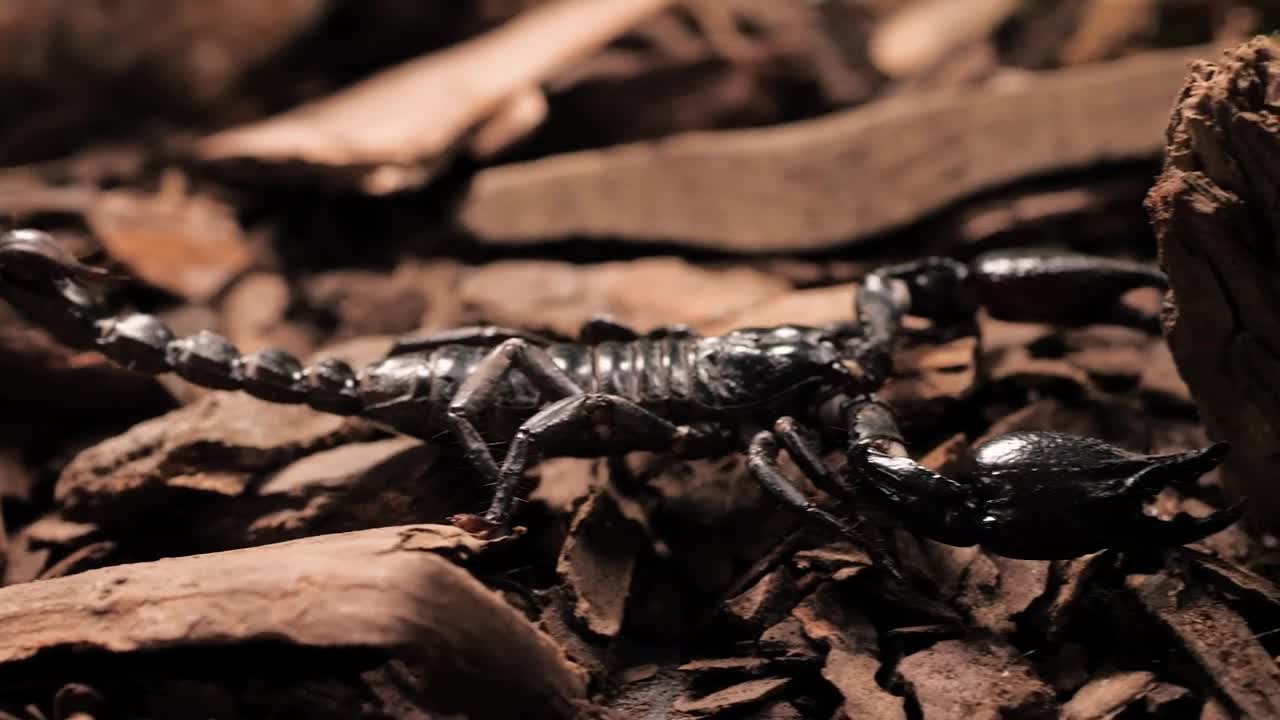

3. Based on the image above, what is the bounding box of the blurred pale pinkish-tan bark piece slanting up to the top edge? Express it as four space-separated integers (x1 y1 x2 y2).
197 0 673 195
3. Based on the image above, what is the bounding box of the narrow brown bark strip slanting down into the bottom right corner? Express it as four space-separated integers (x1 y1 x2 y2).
1125 570 1280 719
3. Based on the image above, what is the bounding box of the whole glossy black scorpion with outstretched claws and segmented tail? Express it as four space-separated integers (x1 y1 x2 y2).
0 229 1242 559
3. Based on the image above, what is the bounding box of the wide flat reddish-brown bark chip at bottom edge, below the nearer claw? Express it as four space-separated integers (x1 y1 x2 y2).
897 637 1057 720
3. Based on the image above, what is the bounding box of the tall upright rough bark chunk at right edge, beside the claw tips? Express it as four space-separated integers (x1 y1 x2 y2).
1147 37 1280 529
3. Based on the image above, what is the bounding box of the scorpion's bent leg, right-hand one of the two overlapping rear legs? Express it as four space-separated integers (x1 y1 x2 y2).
484 392 721 528
